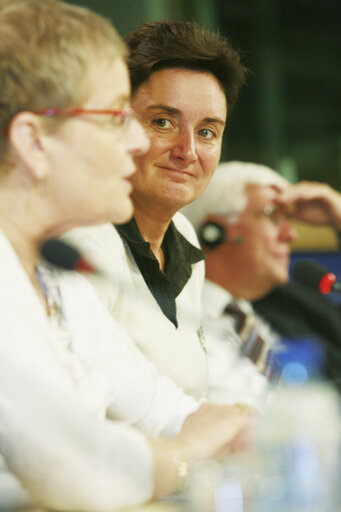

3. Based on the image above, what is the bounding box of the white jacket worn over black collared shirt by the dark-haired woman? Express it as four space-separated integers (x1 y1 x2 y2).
65 213 207 398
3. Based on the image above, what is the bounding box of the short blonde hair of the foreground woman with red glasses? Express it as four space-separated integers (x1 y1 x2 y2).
0 0 127 161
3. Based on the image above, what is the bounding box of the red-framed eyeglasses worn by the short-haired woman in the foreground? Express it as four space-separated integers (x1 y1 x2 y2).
33 108 134 126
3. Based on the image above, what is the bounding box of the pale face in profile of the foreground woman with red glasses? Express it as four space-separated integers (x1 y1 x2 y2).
49 58 149 227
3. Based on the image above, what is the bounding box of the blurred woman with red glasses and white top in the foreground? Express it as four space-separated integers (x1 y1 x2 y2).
0 0 247 512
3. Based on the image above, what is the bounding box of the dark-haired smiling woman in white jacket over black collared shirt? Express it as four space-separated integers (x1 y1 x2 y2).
62 17 245 398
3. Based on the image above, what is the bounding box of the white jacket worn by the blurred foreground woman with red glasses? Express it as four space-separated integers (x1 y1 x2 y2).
0 232 198 512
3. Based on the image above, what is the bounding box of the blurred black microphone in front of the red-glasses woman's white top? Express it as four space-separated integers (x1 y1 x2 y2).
40 238 96 273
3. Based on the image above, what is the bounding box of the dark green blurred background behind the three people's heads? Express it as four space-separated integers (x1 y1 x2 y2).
65 0 341 190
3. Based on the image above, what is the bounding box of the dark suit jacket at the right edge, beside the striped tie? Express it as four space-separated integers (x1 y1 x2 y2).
253 282 341 391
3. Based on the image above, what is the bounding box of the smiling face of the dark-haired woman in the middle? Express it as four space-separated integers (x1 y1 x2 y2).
131 68 227 213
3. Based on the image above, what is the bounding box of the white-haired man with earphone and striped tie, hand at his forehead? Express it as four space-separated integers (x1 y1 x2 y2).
182 162 341 407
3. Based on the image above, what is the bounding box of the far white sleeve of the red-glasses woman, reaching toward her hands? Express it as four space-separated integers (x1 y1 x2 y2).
61 275 199 437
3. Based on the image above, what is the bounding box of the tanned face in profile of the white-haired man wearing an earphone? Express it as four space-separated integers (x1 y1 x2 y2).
226 185 297 300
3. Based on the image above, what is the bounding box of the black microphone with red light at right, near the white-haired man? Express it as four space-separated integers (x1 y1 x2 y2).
293 260 341 294
